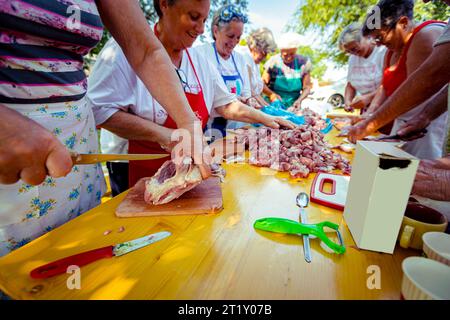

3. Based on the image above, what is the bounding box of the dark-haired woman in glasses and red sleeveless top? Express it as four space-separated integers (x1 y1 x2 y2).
362 0 447 159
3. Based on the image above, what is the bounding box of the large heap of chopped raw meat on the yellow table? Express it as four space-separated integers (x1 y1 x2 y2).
235 125 351 178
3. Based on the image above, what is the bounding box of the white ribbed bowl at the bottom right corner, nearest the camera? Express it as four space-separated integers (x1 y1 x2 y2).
402 257 450 300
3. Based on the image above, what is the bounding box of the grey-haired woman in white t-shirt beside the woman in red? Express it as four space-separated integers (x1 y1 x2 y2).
339 23 386 113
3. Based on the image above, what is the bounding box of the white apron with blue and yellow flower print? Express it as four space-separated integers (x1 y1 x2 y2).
0 99 106 256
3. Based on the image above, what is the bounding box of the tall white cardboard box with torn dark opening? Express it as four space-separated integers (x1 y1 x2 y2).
344 141 419 253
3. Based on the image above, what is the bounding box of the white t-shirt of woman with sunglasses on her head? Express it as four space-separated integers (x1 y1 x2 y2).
193 43 251 98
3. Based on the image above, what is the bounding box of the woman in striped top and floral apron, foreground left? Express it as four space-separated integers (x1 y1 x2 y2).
0 0 208 256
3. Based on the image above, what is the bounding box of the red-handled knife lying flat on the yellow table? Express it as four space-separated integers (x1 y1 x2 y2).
30 231 171 279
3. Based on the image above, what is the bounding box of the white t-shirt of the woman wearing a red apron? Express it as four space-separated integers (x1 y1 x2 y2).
86 39 236 152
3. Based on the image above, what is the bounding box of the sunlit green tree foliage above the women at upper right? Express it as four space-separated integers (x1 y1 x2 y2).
294 0 450 65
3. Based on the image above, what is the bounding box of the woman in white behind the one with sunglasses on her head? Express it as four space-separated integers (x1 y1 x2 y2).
236 28 281 106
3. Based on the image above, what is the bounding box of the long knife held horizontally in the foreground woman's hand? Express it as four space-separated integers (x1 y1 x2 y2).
70 152 170 165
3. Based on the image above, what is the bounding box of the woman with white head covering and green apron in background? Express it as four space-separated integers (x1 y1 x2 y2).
262 33 311 109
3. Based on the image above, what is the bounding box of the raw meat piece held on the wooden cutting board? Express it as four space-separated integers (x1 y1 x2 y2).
144 158 203 205
